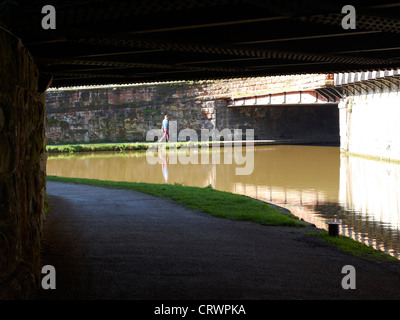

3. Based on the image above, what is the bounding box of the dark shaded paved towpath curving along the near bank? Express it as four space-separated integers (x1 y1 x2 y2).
39 182 400 300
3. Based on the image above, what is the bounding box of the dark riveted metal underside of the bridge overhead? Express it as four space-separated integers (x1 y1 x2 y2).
0 0 400 87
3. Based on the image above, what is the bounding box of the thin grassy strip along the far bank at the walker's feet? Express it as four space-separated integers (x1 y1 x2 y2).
46 141 219 153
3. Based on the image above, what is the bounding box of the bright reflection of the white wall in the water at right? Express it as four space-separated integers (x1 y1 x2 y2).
337 155 400 257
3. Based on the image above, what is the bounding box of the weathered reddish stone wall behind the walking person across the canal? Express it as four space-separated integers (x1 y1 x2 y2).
46 83 223 143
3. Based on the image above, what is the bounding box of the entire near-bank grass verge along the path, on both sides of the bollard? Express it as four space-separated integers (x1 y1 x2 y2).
47 176 398 261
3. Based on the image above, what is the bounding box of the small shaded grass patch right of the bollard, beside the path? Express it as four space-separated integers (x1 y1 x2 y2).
306 231 399 261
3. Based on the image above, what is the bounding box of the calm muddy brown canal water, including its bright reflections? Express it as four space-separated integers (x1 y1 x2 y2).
47 145 400 258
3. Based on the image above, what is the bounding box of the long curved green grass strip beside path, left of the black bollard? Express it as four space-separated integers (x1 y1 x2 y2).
47 176 305 226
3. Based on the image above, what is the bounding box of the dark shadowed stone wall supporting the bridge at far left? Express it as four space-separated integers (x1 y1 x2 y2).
0 28 46 300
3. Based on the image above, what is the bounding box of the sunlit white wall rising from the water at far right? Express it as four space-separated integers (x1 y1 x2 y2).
339 89 400 160
